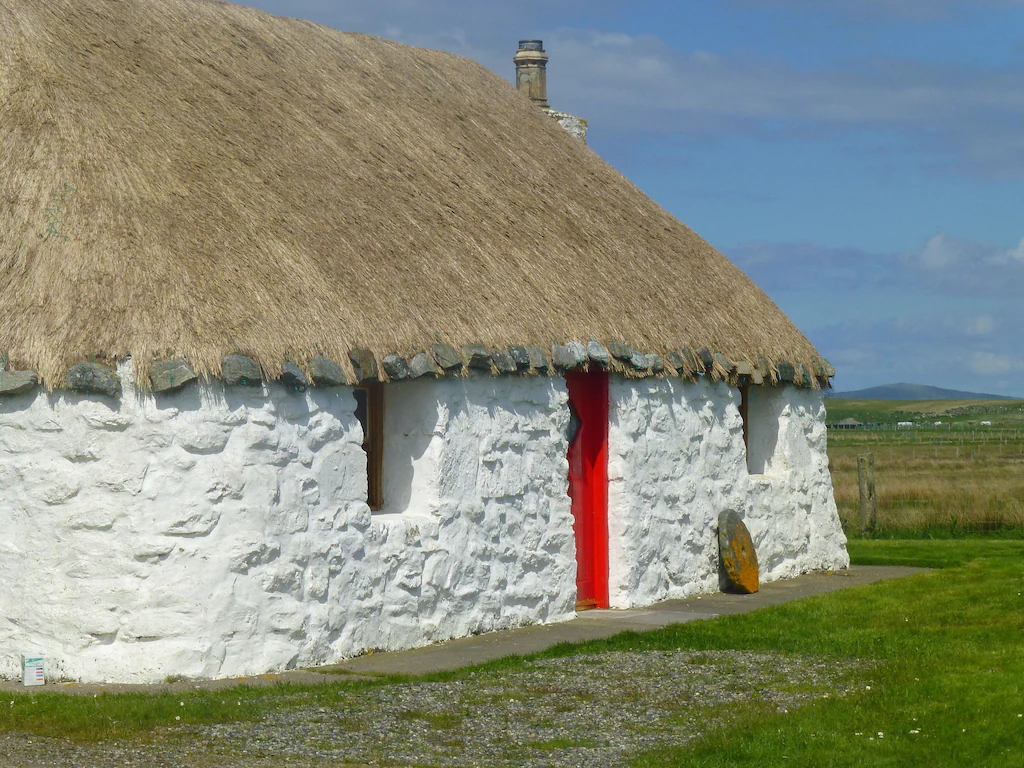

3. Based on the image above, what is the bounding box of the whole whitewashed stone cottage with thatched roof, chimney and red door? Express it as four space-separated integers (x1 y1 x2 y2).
0 0 848 682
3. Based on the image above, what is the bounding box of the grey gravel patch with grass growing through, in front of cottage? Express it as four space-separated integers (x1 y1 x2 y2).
0 651 864 768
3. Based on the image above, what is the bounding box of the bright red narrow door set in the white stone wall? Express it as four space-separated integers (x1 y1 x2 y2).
565 371 608 608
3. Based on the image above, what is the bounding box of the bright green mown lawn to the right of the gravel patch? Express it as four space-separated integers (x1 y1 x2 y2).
622 539 1024 768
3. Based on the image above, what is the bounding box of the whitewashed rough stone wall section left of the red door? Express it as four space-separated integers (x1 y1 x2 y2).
0 366 575 682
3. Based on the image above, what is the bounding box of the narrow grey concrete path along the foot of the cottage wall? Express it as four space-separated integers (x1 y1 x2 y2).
0 565 928 695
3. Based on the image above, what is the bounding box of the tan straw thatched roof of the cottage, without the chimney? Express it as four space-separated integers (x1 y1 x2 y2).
0 0 817 386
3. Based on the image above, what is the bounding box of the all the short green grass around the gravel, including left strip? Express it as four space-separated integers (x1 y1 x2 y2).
0 538 1024 768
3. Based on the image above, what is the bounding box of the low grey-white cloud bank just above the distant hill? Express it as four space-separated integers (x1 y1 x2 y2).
728 232 1024 396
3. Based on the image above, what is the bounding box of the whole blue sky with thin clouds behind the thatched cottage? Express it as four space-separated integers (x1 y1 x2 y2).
248 0 1024 396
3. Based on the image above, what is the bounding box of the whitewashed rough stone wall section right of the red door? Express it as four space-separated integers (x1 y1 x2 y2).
608 377 849 608
